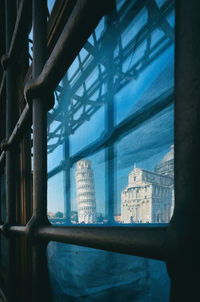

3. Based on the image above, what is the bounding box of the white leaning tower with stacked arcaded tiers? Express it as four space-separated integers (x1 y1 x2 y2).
76 159 96 223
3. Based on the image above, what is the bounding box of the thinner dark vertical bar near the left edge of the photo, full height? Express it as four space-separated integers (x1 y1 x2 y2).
5 0 18 302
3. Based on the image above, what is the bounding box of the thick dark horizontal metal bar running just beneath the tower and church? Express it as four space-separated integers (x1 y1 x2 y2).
0 224 168 261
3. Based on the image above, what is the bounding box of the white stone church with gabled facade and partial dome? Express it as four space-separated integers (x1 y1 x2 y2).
121 147 174 223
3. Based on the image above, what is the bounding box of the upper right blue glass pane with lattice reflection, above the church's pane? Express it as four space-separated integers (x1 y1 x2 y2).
113 1 174 124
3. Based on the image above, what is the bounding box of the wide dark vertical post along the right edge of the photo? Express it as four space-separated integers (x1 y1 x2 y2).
166 0 200 301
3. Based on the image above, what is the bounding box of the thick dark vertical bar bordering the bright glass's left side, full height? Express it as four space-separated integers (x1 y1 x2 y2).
32 0 50 302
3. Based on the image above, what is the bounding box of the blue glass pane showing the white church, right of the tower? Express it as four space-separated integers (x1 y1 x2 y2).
115 105 174 223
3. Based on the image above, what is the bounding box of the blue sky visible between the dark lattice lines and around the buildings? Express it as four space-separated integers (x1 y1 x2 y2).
48 2 174 219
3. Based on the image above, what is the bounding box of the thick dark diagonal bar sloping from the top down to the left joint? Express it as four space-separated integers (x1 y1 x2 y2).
25 0 110 99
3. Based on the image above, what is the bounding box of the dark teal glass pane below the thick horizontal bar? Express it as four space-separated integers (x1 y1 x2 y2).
47 242 169 302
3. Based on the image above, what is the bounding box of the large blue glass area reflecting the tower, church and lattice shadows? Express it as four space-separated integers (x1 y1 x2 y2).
48 0 174 224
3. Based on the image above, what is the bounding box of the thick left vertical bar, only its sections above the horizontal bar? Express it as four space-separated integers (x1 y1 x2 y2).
32 0 47 221
